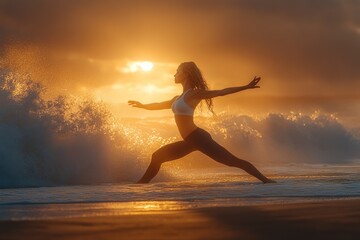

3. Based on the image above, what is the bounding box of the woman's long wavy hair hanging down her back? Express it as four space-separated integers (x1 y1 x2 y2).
179 62 214 114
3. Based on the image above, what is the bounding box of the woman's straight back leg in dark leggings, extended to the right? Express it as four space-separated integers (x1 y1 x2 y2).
187 129 275 183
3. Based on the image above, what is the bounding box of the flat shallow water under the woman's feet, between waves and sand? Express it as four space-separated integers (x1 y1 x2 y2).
0 164 360 220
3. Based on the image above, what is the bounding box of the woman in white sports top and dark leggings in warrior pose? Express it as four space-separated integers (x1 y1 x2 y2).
128 62 274 183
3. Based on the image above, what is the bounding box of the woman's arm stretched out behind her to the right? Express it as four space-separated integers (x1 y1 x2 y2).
194 76 261 99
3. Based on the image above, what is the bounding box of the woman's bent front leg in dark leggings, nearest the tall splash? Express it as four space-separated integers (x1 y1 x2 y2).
137 141 196 183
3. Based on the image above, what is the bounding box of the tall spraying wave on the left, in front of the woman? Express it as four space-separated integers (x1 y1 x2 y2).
0 72 172 188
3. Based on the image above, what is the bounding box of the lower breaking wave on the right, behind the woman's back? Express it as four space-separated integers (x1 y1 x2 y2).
204 111 360 163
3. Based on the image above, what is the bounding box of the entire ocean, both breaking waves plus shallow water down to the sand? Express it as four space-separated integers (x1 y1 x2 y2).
0 74 360 220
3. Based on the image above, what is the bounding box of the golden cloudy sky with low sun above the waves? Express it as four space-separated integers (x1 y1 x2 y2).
0 0 360 120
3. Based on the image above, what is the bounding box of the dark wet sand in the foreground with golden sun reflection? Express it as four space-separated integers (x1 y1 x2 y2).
0 199 360 240
